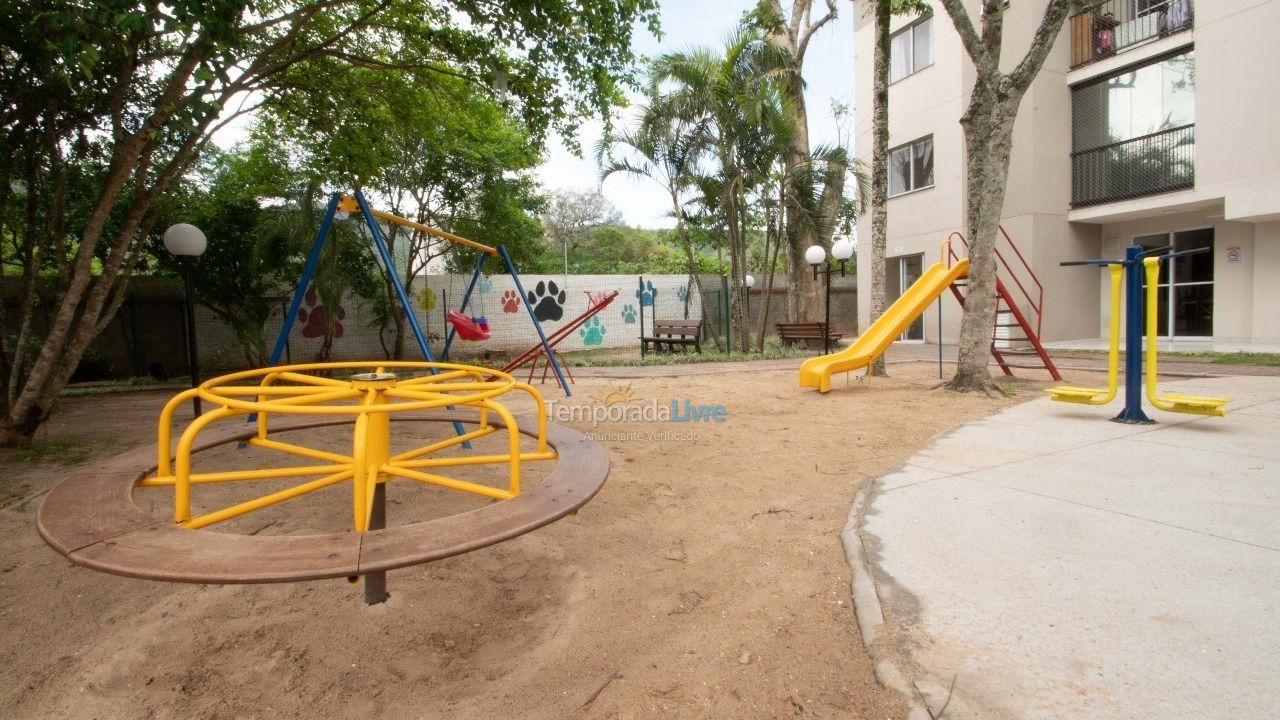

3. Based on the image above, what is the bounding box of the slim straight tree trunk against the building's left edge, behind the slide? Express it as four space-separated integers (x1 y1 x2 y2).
869 0 892 375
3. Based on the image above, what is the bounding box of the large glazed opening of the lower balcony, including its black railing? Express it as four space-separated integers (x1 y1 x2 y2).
1071 50 1196 208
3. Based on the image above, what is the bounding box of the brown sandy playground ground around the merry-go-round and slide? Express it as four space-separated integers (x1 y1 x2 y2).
0 364 1087 720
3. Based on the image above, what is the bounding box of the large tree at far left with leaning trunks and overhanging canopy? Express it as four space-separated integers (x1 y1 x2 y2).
0 0 657 445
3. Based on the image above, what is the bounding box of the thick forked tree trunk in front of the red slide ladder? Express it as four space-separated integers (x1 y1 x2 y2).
942 0 1071 392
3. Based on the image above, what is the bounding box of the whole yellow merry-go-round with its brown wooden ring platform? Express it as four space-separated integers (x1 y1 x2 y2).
37 361 609 603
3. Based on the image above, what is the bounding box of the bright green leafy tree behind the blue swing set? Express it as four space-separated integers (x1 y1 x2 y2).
255 68 541 359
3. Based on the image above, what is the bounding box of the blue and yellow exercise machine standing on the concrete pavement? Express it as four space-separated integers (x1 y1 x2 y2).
1044 245 1231 424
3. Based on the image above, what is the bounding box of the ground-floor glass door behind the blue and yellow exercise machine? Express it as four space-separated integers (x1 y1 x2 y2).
1134 228 1213 340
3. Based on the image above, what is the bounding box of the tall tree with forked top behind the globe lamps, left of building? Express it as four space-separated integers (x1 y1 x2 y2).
755 0 844 323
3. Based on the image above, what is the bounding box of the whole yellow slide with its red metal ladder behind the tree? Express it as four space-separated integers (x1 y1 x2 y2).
800 227 1062 392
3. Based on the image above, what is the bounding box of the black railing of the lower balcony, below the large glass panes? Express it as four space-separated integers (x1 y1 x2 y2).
1071 124 1196 208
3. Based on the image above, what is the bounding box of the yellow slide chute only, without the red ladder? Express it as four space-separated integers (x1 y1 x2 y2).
800 258 969 392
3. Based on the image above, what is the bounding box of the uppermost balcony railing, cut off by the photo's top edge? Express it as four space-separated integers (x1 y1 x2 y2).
1071 0 1194 69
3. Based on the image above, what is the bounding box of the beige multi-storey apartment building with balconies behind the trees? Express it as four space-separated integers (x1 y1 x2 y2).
854 0 1280 348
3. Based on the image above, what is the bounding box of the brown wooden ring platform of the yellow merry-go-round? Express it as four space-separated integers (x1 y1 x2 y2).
36 411 609 583
